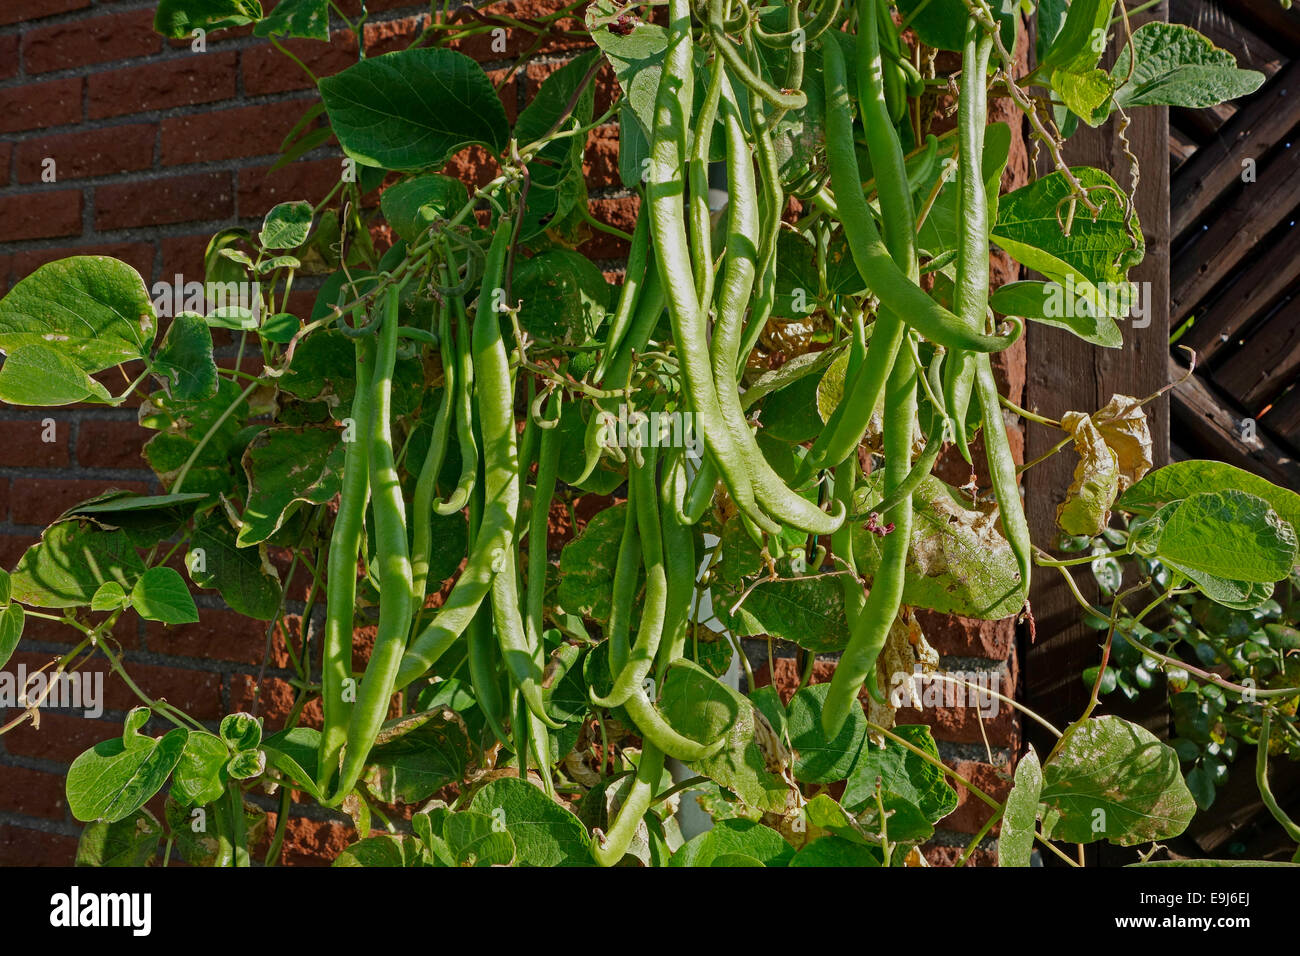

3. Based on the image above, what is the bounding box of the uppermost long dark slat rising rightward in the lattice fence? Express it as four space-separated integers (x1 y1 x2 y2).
1170 62 1300 241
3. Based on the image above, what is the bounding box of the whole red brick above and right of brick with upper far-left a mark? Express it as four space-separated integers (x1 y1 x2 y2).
90 51 237 120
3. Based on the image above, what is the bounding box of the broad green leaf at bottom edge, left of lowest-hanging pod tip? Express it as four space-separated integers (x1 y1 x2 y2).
469 777 592 866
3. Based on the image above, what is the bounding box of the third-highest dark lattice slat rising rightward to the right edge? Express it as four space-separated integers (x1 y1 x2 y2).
1180 218 1300 365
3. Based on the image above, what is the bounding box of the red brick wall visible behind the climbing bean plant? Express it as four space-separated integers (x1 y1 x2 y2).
0 0 1023 865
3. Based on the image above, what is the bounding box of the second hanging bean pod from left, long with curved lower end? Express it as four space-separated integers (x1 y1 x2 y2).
333 287 413 804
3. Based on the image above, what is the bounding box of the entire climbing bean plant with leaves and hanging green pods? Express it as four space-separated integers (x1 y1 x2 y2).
0 0 1300 866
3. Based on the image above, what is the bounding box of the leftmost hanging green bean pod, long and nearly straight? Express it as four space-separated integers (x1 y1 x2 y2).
317 312 374 793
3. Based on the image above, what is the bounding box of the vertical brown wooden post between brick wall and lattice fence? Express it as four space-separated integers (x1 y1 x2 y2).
1024 8 1170 732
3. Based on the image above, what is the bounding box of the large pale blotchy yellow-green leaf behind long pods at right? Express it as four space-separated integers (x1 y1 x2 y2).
853 476 1024 620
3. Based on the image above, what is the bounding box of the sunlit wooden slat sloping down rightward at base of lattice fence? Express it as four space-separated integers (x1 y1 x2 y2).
1169 356 1300 488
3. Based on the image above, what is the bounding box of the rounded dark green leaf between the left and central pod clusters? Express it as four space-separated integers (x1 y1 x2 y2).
511 248 610 345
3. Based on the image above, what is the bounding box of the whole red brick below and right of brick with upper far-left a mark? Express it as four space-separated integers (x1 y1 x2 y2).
95 172 234 230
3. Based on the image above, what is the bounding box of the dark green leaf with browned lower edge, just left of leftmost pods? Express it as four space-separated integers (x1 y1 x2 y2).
235 425 347 548
